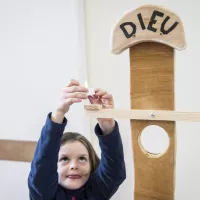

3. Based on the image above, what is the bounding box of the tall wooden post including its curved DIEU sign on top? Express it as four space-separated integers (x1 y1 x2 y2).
112 5 185 200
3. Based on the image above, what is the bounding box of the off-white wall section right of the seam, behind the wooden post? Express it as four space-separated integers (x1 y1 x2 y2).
85 0 200 200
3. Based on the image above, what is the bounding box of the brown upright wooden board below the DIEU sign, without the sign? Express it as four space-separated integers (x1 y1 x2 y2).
130 42 176 200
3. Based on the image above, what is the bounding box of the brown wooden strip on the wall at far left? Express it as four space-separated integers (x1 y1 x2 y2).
0 140 37 162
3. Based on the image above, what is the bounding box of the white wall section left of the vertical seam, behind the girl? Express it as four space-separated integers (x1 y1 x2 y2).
0 0 90 200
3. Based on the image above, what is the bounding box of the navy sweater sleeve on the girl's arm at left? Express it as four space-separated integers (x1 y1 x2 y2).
28 113 67 200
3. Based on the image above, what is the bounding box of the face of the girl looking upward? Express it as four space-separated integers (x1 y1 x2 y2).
58 141 91 190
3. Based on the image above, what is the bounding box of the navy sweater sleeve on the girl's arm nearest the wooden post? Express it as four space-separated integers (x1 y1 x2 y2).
94 121 126 199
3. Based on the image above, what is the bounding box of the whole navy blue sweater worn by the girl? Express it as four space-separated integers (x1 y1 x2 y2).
28 113 126 200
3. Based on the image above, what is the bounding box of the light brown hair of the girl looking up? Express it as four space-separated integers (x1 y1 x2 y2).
61 132 100 173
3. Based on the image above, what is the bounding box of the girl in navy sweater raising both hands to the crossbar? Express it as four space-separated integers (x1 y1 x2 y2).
28 80 126 200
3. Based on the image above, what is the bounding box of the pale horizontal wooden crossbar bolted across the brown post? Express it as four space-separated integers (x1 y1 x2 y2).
85 105 200 122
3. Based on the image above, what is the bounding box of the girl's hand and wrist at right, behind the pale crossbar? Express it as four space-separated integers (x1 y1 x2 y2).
88 89 115 134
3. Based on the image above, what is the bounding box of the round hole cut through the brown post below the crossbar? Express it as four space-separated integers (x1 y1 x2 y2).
140 125 169 155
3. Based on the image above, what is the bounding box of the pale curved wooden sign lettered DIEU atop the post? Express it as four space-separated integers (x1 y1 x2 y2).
111 5 186 54
